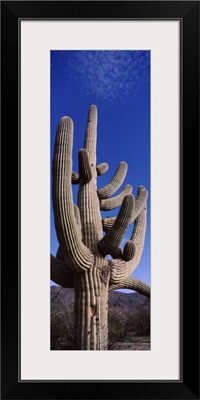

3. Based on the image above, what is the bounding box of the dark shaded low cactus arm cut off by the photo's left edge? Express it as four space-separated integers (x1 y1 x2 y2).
51 254 74 288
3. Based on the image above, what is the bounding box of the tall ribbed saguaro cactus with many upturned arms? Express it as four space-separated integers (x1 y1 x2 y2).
51 105 150 350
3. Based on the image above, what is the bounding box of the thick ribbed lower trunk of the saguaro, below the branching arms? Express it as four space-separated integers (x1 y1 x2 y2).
74 266 108 350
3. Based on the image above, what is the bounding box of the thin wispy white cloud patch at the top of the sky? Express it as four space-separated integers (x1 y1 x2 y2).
60 51 150 103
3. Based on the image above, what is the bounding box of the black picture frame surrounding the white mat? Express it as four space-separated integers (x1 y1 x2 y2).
1 1 200 399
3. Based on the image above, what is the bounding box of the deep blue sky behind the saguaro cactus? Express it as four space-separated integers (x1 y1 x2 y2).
51 50 150 290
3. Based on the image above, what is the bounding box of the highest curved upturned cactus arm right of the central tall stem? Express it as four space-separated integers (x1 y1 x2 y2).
97 161 128 199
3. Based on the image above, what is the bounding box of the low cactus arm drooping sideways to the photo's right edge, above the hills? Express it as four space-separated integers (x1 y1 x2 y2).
109 276 151 298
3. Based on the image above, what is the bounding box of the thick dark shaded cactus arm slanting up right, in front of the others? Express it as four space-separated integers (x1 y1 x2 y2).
98 194 135 255
